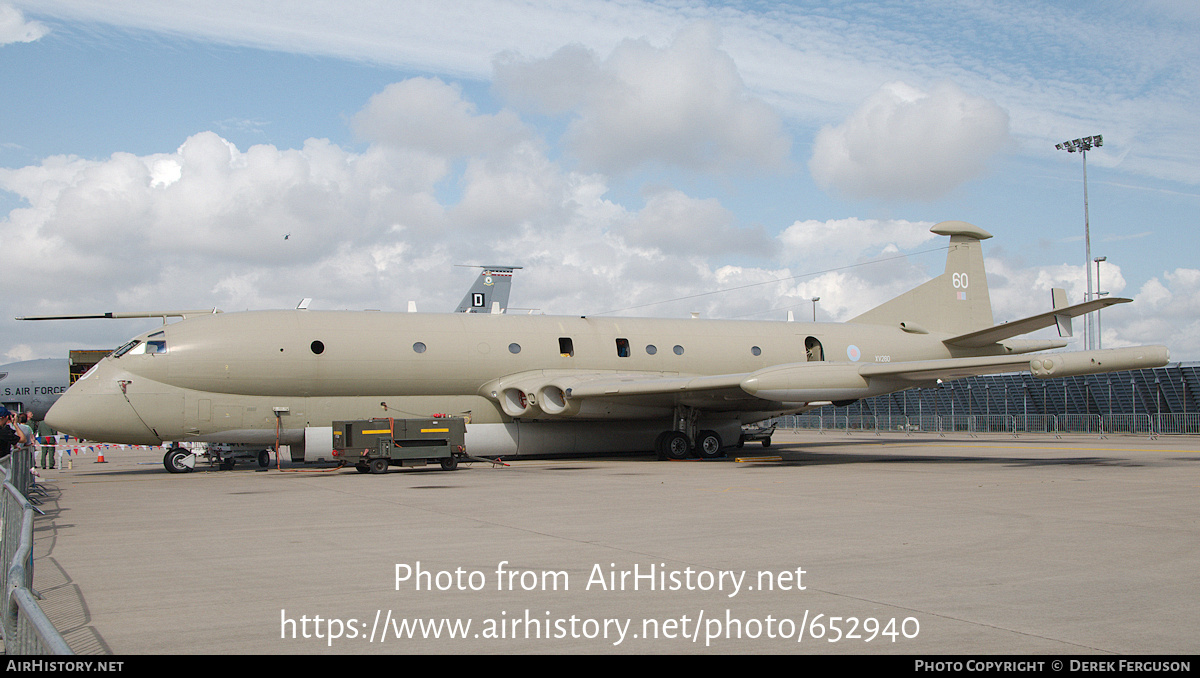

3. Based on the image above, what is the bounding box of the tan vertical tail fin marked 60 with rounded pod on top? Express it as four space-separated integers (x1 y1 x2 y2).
851 221 992 335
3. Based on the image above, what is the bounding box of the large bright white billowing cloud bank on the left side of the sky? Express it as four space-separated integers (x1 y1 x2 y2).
0 132 445 314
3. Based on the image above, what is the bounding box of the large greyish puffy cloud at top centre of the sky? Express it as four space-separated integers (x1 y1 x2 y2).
494 23 791 174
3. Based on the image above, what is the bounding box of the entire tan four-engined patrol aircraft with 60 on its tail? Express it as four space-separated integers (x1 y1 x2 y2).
47 221 1170 472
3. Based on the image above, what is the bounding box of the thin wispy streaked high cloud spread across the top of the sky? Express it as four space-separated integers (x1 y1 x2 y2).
12 0 1200 184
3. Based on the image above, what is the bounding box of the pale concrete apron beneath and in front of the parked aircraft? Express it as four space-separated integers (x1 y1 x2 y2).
25 433 1200 654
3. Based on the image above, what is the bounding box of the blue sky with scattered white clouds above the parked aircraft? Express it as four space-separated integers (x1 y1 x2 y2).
0 0 1200 360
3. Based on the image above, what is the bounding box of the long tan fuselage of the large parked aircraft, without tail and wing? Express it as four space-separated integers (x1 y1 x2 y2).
50 311 952 454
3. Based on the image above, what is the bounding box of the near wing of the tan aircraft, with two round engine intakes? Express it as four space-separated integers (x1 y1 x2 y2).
494 346 1170 416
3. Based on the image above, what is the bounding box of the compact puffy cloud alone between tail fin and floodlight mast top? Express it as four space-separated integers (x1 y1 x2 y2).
809 82 1009 200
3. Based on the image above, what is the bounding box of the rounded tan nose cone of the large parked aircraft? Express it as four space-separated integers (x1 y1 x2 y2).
46 364 162 445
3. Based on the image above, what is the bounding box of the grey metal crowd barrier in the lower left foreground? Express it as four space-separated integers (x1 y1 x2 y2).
0 449 74 654
